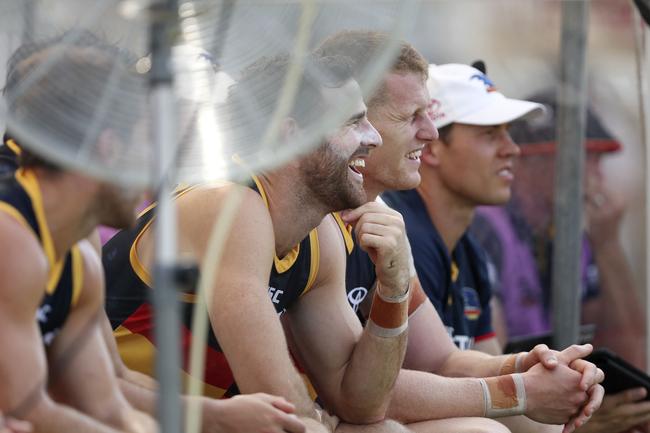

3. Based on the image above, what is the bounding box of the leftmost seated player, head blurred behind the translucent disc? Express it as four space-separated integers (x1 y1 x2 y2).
0 33 156 432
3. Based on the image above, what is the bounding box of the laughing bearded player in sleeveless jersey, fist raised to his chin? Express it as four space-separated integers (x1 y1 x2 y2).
104 52 436 432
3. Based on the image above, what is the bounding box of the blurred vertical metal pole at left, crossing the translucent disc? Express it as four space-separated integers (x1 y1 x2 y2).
150 0 181 433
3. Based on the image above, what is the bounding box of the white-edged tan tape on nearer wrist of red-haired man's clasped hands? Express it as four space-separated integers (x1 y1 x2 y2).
479 373 526 418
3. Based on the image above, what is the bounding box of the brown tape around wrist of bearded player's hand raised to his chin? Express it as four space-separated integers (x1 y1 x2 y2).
366 285 409 338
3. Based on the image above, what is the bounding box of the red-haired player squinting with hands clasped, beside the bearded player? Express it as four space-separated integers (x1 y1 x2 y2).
319 32 602 432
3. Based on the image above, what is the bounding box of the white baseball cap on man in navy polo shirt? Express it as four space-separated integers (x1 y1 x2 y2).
427 63 544 128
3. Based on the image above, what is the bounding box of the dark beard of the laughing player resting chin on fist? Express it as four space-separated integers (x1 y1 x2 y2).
301 142 366 212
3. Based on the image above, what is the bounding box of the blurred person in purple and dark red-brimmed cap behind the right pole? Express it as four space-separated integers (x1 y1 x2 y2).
472 91 650 433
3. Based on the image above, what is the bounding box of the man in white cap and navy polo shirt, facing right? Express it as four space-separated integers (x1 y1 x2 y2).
382 61 602 432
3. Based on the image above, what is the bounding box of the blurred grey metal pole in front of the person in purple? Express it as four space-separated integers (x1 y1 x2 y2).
553 0 589 350
